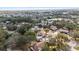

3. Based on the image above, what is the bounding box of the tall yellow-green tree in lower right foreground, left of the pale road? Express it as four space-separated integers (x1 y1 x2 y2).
55 33 70 51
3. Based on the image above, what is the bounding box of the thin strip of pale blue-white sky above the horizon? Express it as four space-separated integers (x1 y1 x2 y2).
0 7 79 10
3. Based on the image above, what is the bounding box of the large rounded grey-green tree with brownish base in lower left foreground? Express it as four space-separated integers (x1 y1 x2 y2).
5 33 31 50
